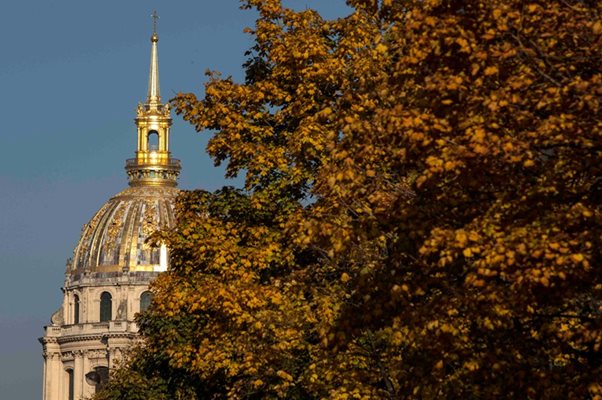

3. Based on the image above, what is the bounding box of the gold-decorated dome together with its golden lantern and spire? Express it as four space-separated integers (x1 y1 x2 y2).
67 25 180 276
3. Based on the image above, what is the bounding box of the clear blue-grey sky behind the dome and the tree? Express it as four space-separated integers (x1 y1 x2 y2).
0 0 348 400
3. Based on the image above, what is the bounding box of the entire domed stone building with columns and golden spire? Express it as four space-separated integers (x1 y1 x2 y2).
40 15 180 400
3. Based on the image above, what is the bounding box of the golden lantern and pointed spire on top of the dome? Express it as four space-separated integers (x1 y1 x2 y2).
125 11 180 186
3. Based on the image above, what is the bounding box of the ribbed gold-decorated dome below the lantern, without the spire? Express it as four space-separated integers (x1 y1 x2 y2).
67 186 179 275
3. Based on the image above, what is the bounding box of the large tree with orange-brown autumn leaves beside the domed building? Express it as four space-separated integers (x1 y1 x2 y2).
98 0 602 399
